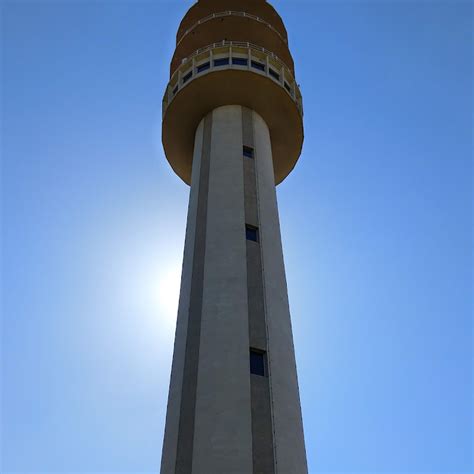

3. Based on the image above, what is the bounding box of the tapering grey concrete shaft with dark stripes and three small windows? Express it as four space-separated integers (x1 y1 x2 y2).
161 105 307 474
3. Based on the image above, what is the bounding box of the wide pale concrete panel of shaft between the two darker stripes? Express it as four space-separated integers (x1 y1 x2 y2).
192 106 252 474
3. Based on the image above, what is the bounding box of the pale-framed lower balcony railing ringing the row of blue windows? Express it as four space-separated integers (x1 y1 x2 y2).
163 41 303 115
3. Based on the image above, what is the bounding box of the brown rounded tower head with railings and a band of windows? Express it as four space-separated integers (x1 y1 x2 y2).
162 0 303 184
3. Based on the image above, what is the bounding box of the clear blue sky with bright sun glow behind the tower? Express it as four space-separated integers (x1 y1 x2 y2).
1 0 474 474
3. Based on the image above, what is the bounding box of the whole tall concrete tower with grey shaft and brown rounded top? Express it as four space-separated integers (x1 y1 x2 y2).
161 0 307 474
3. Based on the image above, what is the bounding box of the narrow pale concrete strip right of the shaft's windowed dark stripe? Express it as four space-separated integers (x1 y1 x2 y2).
253 112 308 474
